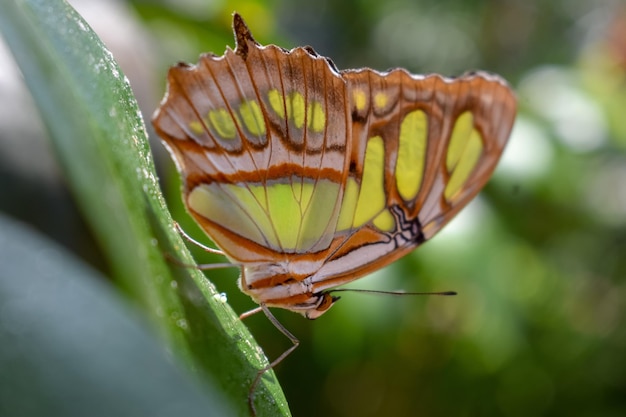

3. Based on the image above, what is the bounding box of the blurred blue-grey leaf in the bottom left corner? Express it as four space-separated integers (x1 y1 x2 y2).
0 215 233 417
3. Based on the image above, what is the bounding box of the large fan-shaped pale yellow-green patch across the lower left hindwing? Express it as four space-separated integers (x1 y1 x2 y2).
187 179 340 252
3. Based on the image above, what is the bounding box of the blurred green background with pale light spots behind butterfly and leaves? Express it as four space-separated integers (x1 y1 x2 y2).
0 0 626 416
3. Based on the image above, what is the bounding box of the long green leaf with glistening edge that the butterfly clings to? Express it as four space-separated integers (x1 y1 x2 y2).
0 0 289 415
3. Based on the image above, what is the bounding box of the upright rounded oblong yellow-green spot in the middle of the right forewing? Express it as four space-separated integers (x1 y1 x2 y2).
396 110 428 201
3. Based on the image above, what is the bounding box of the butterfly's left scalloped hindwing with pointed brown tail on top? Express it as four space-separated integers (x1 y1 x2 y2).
154 15 351 264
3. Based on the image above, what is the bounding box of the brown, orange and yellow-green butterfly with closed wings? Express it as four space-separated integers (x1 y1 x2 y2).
153 9 516 410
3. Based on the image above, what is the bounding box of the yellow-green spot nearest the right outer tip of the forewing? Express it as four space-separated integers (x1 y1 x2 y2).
444 112 484 200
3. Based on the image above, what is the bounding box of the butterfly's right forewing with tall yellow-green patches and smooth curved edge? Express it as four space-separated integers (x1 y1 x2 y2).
313 69 516 291
